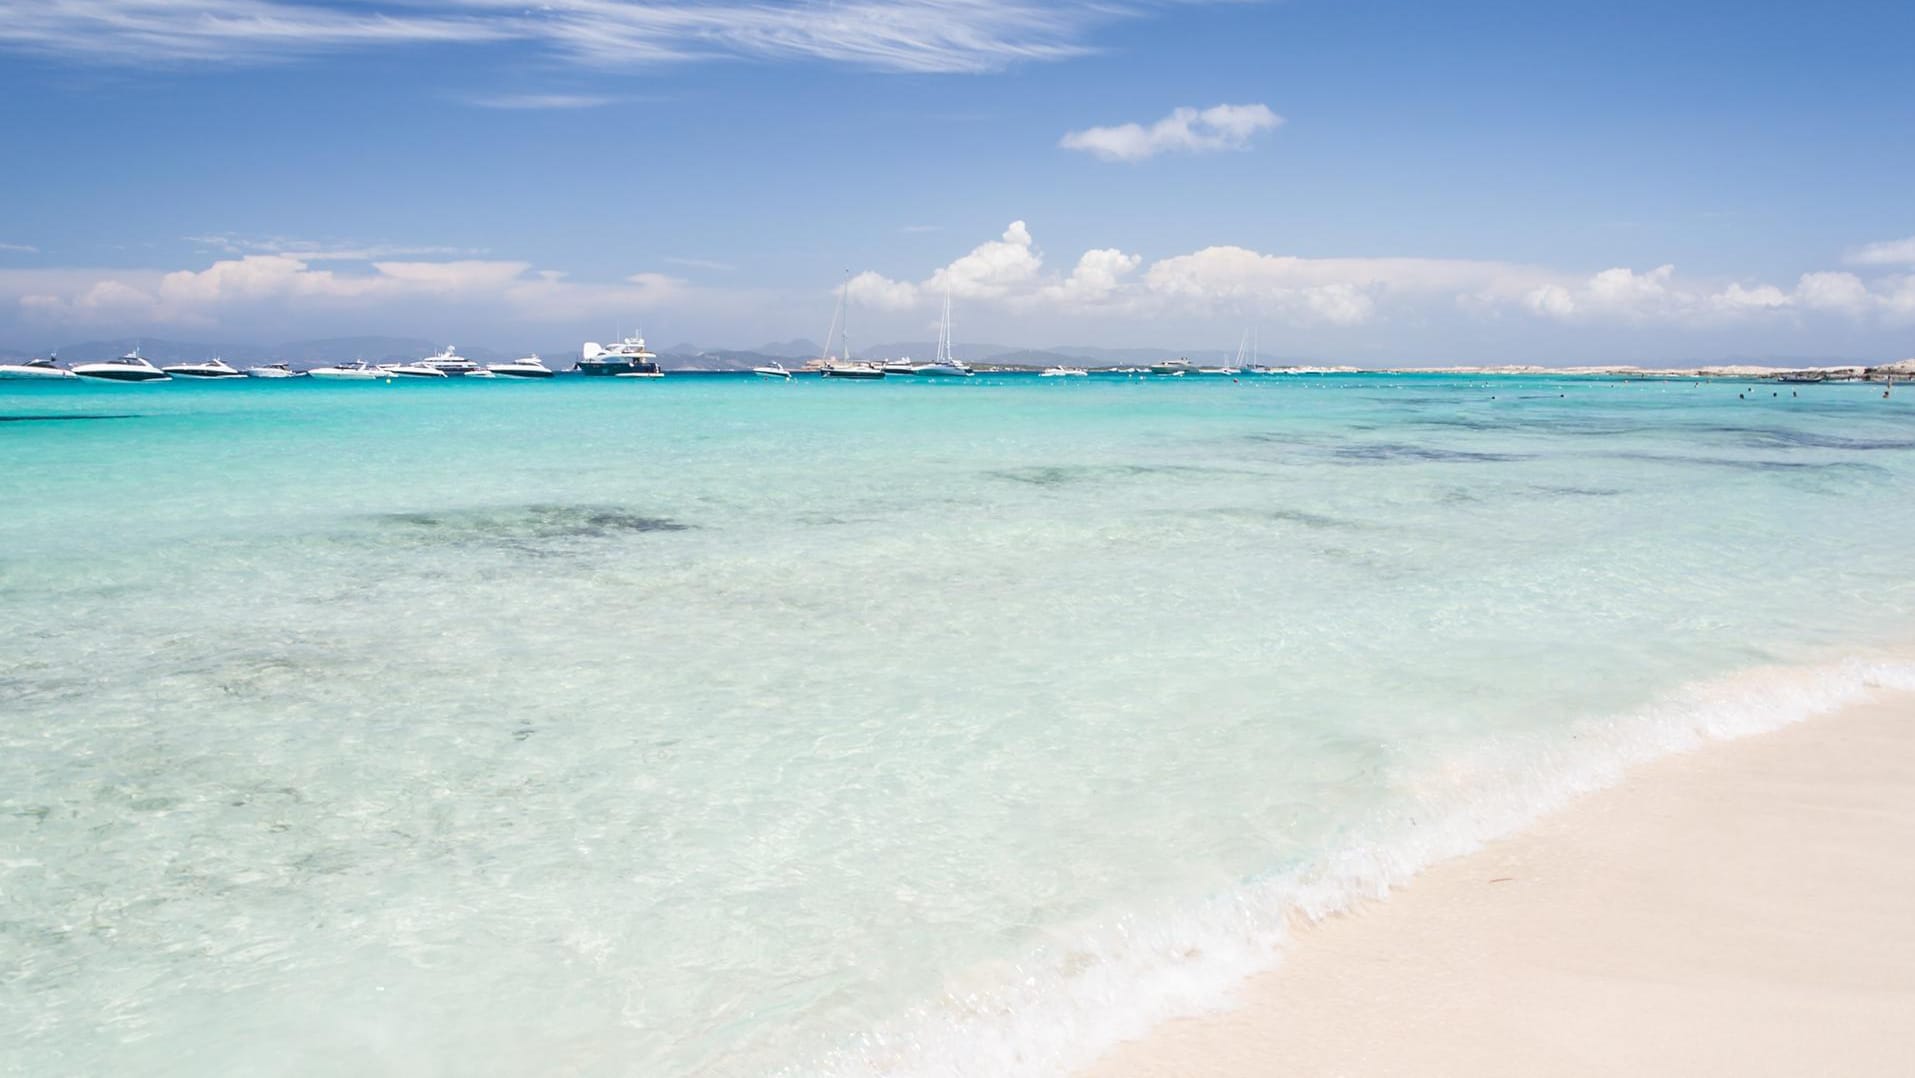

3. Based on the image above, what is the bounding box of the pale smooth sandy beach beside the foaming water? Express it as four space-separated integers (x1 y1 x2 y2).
1080 689 1915 1078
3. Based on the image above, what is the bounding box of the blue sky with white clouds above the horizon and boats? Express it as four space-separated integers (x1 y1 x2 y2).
0 0 1915 364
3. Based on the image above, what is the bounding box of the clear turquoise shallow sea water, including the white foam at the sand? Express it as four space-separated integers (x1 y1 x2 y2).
0 375 1915 1074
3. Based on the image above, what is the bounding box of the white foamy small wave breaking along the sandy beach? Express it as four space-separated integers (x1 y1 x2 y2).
781 659 1915 1078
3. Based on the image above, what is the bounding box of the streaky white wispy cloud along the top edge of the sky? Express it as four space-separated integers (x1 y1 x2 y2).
0 0 1160 73
